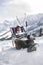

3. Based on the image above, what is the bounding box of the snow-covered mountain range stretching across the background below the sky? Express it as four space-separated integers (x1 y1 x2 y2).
0 14 43 39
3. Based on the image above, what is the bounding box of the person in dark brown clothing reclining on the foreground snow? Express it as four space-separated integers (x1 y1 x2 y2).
15 35 34 49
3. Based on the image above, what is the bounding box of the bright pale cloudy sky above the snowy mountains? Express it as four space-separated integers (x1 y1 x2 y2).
0 0 43 22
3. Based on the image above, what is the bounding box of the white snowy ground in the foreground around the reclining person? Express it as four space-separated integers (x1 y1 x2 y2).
0 36 43 65
